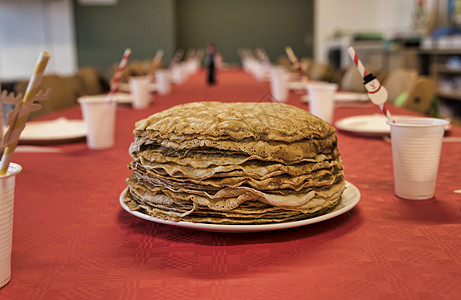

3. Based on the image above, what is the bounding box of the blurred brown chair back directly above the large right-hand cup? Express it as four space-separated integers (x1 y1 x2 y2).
403 76 437 115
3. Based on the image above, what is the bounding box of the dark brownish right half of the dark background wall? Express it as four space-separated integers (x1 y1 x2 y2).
176 0 313 63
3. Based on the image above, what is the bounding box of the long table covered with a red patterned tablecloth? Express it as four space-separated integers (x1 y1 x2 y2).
0 68 461 299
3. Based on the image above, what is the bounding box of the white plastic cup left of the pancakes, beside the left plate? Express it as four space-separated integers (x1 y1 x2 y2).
78 96 117 149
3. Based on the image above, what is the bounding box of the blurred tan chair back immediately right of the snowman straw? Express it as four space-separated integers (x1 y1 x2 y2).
381 69 418 103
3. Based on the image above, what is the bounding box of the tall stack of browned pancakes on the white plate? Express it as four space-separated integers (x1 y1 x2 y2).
123 102 345 224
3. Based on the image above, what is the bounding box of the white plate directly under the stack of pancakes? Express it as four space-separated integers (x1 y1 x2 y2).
119 181 360 232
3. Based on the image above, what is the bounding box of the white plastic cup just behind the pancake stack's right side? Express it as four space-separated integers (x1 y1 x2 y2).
307 82 338 123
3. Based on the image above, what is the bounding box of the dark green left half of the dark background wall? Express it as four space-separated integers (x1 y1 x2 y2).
74 0 176 72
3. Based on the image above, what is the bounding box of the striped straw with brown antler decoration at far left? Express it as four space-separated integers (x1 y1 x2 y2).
0 51 50 175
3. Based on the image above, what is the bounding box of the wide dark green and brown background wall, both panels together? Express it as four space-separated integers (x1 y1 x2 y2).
75 0 313 69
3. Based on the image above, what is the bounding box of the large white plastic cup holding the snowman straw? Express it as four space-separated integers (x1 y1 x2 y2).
387 118 448 200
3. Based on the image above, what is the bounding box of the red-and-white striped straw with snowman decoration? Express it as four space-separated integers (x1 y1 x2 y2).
348 47 395 123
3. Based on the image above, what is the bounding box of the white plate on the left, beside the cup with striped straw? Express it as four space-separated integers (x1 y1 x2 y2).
19 118 86 143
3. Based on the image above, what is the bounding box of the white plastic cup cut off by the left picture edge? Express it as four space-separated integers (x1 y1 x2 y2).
0 163 22 287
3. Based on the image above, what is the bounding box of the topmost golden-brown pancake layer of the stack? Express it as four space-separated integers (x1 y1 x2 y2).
134 102 335 143
